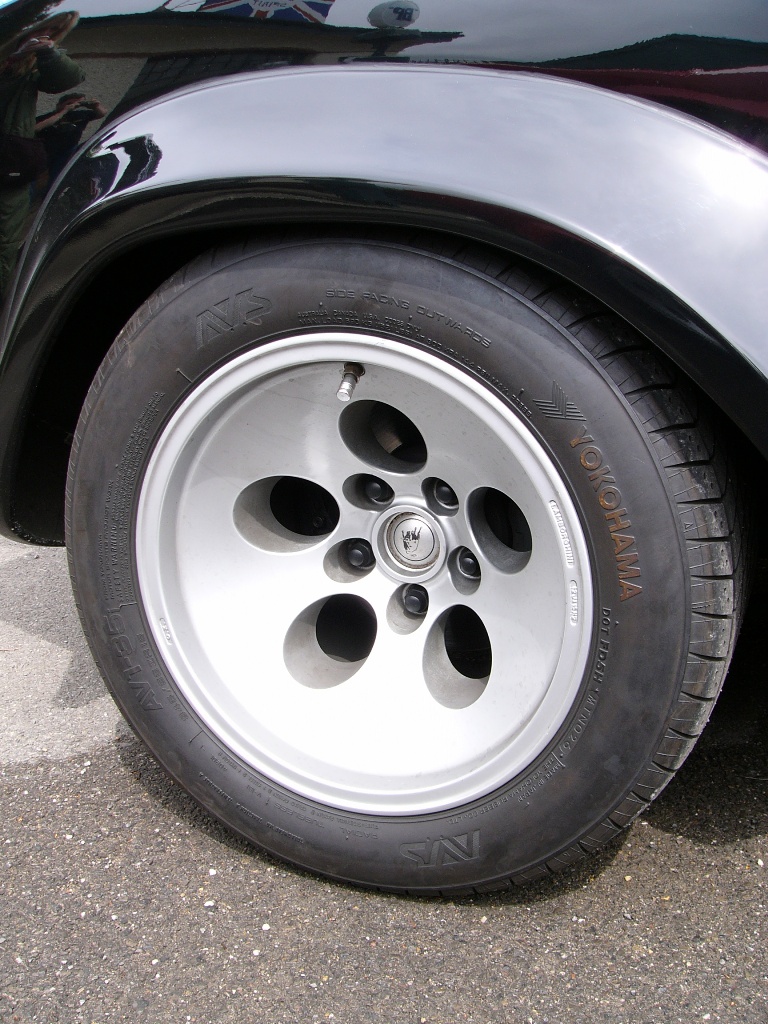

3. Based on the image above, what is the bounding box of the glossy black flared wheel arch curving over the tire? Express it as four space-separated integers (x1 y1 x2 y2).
0 67 768 541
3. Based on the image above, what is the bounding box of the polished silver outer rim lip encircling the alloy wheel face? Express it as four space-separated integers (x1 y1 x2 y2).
134 330 594 816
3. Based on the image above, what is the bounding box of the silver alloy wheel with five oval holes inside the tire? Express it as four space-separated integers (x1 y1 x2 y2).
135 331 593 815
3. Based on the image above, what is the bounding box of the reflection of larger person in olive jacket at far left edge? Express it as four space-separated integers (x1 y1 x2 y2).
0 11 85 296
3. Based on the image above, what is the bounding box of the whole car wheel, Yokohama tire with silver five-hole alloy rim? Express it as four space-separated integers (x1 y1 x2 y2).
68 237 741 893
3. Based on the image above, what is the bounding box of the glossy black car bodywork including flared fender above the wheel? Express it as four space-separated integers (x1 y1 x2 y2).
0 0 768 537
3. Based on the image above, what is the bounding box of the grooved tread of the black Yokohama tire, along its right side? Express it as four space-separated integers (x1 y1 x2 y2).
495 275 746 881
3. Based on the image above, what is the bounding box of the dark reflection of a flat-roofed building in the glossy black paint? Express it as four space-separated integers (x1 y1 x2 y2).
68 13 462 117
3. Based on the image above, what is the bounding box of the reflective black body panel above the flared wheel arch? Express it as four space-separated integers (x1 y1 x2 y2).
0 0 768 311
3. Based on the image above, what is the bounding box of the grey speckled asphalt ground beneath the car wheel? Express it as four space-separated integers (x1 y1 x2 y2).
0 541 768 1024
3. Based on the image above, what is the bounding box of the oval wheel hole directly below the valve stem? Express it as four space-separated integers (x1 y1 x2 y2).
340 401 427 473
